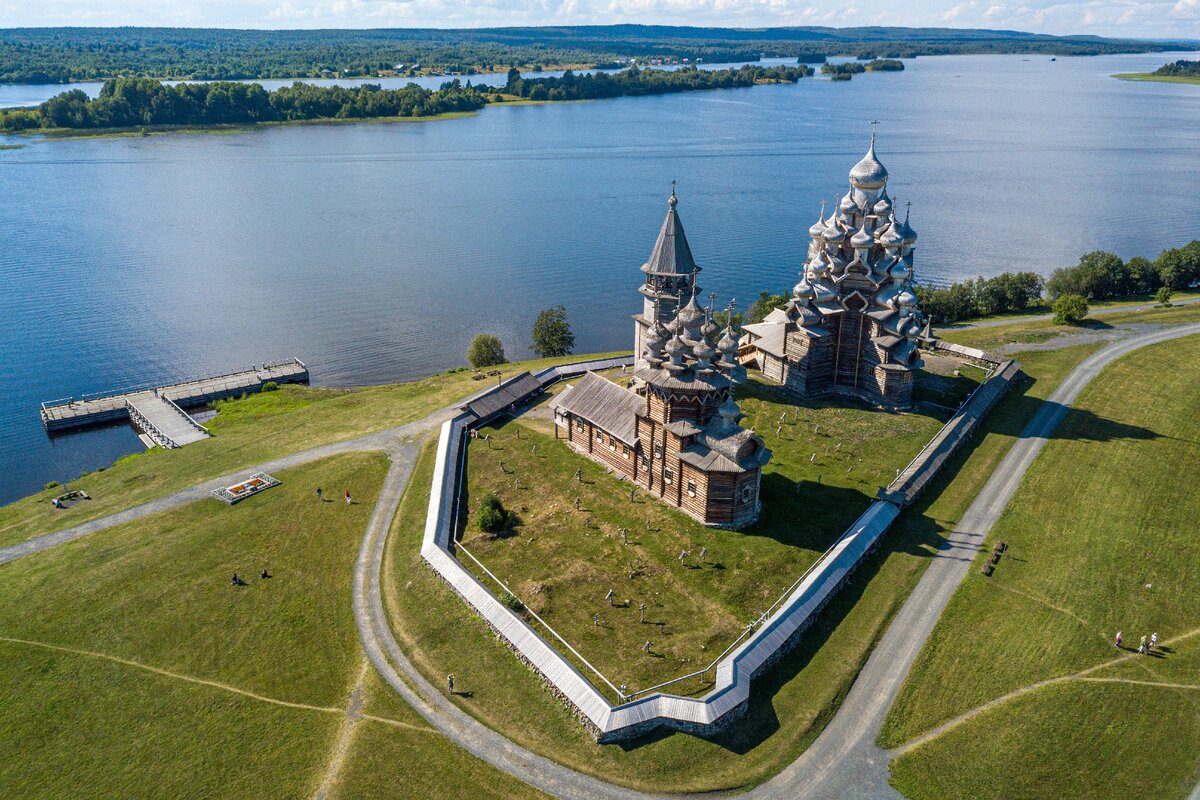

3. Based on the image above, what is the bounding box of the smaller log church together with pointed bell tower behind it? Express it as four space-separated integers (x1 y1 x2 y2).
551 188 770 529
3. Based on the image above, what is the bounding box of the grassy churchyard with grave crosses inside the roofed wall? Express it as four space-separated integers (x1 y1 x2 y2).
462 383 942 699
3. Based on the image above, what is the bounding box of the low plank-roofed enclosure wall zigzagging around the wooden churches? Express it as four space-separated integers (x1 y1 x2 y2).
421 350 1019 741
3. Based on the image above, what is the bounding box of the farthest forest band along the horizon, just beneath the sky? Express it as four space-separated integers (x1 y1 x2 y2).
0 25 1181 83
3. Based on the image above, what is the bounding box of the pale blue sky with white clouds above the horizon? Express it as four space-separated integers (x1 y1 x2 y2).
0 0 1200 38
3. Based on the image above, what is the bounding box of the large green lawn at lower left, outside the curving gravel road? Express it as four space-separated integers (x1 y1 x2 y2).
0 455 549 799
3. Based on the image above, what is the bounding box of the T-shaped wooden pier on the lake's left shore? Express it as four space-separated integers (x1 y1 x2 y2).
42 359 308 449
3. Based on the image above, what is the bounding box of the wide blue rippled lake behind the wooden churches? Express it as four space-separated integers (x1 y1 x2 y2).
0 54 1200 501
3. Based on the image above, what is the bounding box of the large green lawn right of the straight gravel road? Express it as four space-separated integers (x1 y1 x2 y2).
881 337 1200 798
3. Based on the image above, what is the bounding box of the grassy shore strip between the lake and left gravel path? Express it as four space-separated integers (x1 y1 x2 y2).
0 356 628 547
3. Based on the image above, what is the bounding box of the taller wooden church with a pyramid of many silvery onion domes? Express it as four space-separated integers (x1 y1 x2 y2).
743 132 930 409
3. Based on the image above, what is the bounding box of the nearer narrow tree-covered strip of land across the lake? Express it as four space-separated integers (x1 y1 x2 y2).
0 65 812 131
